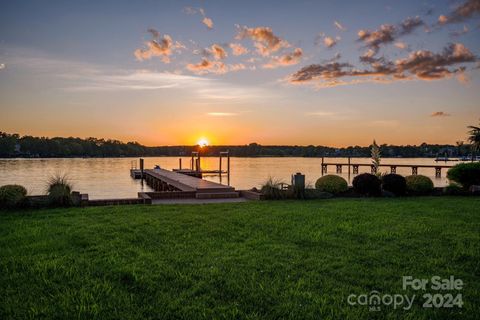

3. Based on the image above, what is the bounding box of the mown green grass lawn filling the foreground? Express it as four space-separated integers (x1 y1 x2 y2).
0 197 480 319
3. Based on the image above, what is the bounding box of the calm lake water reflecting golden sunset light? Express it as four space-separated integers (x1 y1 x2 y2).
0 157 456 199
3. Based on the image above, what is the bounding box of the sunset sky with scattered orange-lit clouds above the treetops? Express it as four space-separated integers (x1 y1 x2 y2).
0 0 480 146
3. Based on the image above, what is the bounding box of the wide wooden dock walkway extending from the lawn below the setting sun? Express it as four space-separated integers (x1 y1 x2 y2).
143 169 238 199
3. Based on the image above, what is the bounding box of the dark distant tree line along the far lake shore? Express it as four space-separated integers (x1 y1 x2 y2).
0 132 470 158
